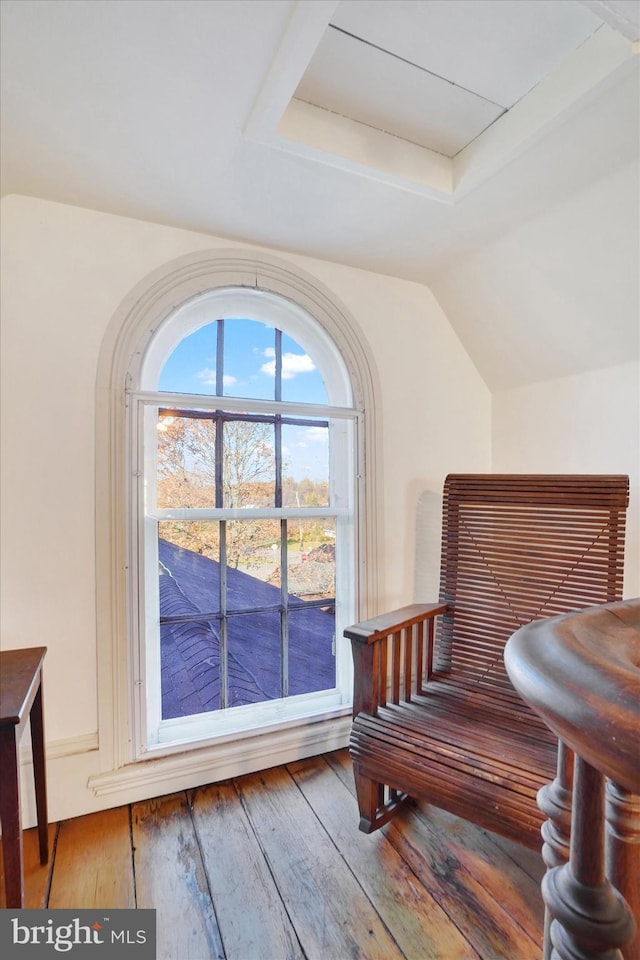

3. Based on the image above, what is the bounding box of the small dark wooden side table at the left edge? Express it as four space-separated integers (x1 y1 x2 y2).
0 647 49 908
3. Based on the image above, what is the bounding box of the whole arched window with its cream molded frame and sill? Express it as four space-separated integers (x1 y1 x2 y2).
90 249 381 796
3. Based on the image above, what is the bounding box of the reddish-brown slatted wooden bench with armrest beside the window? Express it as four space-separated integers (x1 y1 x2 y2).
345 474 628 849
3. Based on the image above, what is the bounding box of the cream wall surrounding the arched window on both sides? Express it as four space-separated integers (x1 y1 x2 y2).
0 196 491 821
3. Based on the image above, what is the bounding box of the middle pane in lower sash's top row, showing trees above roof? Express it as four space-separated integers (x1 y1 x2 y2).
226 520 280 610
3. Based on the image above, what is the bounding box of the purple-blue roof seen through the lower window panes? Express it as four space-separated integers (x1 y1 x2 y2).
159 540 335 720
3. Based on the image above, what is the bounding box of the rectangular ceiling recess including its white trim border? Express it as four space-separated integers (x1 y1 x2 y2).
245 0 638 204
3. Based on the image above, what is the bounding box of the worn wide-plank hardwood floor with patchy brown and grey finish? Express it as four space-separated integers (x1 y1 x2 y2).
2 751 543 960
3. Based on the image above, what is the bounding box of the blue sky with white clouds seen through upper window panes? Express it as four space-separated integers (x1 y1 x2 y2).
158 319 329 480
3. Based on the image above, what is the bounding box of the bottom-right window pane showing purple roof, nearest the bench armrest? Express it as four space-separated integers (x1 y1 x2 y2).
289 604 336 696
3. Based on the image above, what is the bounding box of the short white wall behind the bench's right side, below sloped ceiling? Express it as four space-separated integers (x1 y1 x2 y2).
493 361 640 598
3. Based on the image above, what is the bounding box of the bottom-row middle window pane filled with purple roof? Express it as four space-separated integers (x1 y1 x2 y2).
228 613 282 706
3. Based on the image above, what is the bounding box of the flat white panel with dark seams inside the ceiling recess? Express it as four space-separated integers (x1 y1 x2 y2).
295 0 602 158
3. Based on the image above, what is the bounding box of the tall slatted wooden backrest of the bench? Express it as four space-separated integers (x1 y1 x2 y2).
435 474 628 700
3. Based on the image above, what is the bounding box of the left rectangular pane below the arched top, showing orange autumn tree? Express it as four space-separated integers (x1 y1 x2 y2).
157 414 216 508
